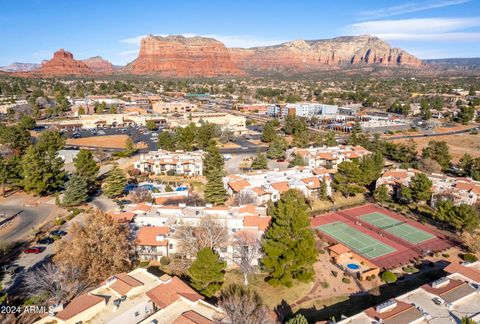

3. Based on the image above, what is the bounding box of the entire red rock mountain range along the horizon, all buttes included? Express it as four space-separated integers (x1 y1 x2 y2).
3 35 432 77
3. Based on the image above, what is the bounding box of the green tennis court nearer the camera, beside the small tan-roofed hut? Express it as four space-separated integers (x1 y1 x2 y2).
317 222 396 259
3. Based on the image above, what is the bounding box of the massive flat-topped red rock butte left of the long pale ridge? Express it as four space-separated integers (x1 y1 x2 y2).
124 36 243 77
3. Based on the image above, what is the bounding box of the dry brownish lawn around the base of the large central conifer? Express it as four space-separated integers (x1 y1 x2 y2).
224 270 314 308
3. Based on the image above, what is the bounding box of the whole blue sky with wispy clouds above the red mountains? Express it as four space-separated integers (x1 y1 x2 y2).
0 0 480 65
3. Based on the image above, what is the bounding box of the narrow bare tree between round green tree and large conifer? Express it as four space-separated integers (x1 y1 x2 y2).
233 231 261 285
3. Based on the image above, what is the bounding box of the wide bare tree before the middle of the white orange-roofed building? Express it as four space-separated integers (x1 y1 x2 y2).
174 216 228 258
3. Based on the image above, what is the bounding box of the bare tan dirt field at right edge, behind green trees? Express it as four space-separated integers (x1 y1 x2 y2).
393 134 480 162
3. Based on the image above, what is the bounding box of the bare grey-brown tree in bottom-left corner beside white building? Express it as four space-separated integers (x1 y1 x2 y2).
24 263 89 305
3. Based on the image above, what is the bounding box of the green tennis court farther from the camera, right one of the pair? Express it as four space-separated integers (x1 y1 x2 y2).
358 212 435 244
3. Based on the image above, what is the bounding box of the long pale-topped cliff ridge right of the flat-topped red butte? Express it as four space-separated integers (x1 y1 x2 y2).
230 35 422 73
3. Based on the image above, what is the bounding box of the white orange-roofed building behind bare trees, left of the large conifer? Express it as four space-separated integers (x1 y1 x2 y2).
116 203 271 264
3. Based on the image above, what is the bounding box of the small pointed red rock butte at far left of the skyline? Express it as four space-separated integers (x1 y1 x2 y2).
29 48 94 76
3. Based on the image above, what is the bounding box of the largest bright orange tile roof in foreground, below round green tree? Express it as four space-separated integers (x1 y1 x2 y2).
147 277 203 308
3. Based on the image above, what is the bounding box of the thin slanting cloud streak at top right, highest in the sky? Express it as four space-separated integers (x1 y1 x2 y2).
359 0 471 19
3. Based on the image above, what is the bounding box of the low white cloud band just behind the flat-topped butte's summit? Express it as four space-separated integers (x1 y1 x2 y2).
120 33 285 48
